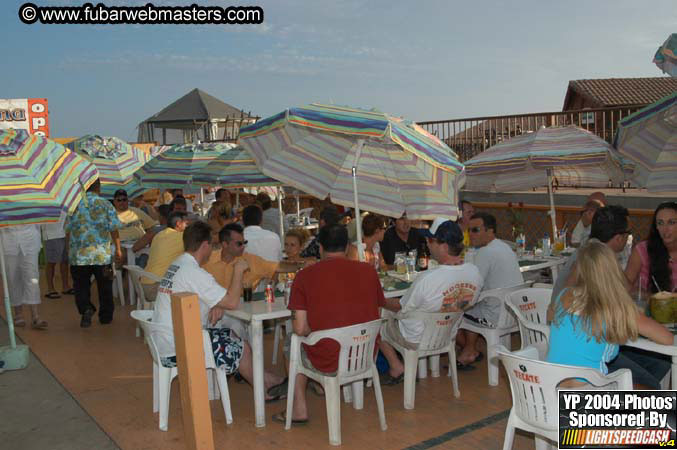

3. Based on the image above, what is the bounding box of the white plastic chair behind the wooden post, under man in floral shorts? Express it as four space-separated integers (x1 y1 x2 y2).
131 310 233 431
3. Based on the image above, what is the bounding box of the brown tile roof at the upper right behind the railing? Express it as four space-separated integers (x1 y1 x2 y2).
562 77 677 111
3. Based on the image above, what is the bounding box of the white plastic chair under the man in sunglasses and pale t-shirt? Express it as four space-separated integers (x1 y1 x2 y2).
460 282 532 386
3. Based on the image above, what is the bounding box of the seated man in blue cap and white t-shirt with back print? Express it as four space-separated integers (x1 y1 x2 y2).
380 217 483 385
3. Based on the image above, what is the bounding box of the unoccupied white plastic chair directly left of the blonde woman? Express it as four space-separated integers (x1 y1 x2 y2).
506 288 552 359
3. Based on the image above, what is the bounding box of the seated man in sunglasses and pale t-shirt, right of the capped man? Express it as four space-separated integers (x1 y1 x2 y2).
456 212 524 369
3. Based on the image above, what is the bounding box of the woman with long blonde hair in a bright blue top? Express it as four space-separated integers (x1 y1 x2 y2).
546 239 673 374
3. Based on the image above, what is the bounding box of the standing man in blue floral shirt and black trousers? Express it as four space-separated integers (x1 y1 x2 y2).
66 179 122 328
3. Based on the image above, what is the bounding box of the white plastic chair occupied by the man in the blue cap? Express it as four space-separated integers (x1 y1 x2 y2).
382 311 463 409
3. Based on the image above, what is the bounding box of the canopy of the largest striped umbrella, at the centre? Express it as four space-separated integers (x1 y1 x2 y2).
239 104 463 219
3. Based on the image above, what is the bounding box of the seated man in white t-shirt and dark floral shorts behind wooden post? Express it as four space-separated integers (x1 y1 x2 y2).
153 221 287 400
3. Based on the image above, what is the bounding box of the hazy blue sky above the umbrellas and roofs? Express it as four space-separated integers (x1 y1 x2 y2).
0 0 677 141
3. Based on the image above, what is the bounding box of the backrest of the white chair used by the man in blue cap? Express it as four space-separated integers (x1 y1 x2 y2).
398 311 463 356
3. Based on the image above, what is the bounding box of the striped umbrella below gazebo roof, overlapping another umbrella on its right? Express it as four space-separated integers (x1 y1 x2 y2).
134 143 234 189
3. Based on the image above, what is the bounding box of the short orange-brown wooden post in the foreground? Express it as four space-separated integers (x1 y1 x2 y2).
172 292 214 450
